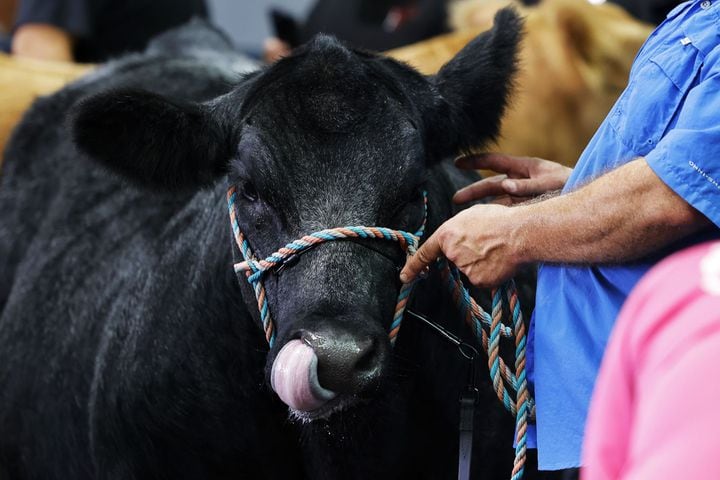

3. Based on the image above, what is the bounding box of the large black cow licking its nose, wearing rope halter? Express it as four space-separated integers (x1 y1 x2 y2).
0 10 540 480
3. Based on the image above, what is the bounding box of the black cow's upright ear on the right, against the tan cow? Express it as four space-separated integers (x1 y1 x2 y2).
427 8 523 157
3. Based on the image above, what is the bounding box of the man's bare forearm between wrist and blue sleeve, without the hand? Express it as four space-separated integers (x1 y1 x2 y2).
513 159 710 263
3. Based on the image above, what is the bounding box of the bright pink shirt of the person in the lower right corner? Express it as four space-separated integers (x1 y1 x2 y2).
581 243 720 480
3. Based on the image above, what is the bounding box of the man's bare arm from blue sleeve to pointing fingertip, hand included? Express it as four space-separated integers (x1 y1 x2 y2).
401 159 710 287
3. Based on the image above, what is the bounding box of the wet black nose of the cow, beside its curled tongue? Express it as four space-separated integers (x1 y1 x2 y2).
302 331 387 394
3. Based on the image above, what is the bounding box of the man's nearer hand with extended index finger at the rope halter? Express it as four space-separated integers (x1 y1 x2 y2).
400 205 523 288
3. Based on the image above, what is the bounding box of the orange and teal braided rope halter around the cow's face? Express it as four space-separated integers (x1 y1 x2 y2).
227 186 427 348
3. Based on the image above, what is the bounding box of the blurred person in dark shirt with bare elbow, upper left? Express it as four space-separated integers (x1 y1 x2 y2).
11 0 207 62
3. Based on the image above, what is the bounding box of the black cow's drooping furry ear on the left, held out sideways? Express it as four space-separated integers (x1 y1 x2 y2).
70 89 234 190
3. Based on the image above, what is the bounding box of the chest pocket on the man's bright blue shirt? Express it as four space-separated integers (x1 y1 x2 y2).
609 41 701 156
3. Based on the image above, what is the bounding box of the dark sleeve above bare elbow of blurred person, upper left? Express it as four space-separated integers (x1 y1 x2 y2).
15 0 93 38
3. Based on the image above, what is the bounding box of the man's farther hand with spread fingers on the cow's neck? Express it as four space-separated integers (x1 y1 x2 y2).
453 153 572 205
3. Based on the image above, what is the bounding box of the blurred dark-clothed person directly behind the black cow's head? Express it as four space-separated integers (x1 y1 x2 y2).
264 0 447 62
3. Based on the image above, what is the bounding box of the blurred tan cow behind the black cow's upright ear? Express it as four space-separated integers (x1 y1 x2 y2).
388 0 652 165
